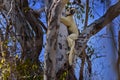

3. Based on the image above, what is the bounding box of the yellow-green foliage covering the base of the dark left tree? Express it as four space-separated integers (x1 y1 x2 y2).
0 33 43 80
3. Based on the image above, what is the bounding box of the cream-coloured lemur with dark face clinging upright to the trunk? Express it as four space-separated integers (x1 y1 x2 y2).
60 7 79 65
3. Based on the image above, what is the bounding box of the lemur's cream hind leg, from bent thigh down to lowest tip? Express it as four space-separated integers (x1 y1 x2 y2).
67 34 78 65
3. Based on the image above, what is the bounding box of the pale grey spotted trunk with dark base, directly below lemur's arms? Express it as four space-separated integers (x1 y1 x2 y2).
56 23 76 80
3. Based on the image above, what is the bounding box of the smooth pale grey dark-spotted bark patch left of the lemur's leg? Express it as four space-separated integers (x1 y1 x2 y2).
56 23 68 72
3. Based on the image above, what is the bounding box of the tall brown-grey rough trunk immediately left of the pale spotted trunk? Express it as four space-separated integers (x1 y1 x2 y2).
44 0 68 80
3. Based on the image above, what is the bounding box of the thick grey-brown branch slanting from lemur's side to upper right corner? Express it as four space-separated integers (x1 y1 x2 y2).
77 1 120 55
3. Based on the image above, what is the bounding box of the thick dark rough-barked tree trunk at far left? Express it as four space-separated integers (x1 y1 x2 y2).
1 0 43 61
